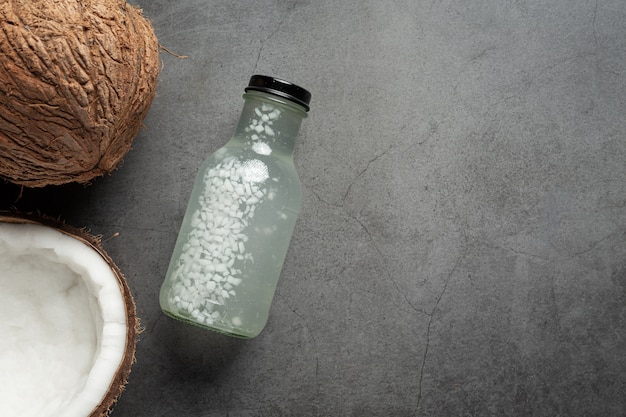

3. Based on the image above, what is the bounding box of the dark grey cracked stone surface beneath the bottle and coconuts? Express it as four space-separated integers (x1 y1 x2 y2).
0 0 626 417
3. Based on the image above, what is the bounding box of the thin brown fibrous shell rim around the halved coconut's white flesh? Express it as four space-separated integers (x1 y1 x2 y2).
0 211 141 417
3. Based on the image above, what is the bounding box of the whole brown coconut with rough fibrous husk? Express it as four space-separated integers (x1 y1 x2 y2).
0 0 159 187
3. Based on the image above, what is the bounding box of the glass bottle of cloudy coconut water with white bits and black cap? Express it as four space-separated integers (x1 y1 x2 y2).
160 75 311 338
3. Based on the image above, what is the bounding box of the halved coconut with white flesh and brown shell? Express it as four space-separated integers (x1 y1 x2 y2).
0 213 138 417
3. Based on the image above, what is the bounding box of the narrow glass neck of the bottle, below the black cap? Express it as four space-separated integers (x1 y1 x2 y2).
231 91 307 155
